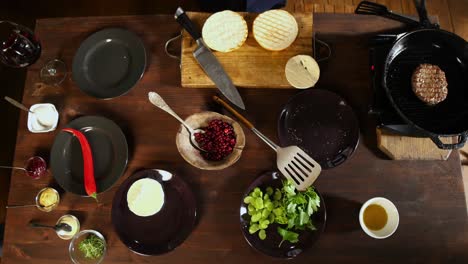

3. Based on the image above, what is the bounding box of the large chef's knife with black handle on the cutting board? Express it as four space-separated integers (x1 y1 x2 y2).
174 7 245 109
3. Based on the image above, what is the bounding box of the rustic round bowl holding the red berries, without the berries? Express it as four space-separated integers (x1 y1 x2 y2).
176 112 245 170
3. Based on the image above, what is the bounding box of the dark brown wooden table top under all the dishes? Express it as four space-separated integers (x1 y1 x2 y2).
3 14 468 264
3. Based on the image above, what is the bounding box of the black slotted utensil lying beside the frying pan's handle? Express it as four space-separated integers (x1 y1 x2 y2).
354 1 420 27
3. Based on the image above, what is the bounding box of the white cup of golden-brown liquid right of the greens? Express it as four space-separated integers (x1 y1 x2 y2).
359 197 400 239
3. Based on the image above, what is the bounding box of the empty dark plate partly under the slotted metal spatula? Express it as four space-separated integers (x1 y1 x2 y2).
278 89 359 169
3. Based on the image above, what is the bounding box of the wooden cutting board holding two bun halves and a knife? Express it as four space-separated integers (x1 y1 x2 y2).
181 12 313 88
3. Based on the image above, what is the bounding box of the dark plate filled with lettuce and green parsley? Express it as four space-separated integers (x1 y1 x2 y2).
240 172 326 259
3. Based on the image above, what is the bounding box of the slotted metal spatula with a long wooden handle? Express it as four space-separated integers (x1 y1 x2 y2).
213 96 322 191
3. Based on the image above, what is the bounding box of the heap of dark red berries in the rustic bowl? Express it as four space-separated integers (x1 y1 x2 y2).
195 119 236 161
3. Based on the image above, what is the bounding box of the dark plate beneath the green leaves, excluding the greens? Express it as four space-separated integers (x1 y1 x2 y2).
240 172 327 258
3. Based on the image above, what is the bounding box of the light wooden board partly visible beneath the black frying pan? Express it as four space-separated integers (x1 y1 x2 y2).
376 128 456 160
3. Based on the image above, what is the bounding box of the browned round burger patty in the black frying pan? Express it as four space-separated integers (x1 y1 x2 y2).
411 63 448 105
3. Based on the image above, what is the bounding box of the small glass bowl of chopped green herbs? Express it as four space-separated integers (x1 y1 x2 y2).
68 230 107 264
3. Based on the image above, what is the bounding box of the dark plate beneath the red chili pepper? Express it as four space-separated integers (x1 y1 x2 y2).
50 116 128 195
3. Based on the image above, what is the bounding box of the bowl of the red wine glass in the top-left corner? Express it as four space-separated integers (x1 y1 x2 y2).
0 21 41 68
